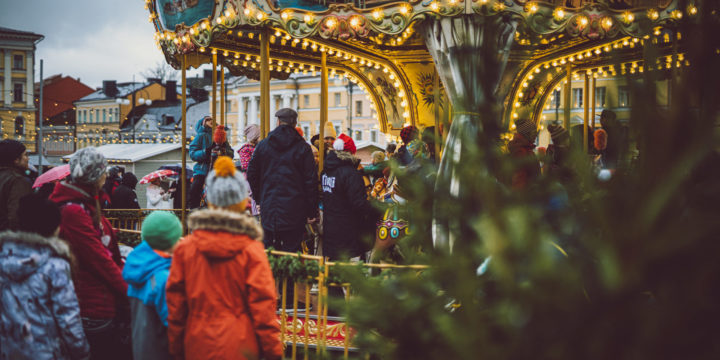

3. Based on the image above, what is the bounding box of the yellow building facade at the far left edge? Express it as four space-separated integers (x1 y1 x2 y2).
0 28 44 153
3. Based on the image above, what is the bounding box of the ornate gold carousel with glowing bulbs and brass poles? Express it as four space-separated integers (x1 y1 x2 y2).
146 0 703 354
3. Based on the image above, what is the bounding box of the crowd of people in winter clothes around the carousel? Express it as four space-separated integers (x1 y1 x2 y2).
0 108 625 359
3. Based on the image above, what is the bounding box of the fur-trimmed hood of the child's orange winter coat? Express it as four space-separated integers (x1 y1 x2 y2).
188 209 263 259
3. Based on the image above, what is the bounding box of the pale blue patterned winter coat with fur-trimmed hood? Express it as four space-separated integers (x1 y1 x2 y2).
0 231 90 360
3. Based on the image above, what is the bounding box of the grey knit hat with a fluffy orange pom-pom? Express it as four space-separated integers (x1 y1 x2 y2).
205 156 249 208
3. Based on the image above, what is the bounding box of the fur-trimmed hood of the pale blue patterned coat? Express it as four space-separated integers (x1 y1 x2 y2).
0 231 72 281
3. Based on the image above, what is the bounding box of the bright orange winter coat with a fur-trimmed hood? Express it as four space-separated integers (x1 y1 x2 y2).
166 208 282 359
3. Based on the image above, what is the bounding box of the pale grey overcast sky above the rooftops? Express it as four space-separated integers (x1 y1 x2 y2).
0 0 202 88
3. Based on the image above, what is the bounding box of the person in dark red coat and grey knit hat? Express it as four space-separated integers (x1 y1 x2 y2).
50 148 132 359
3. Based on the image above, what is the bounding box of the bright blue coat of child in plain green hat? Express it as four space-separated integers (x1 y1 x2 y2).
123 241 171 360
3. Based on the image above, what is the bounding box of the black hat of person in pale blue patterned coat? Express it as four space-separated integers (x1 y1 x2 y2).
17 193 61 237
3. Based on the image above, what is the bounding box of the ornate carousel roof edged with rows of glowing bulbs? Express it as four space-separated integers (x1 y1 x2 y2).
147 0 699 132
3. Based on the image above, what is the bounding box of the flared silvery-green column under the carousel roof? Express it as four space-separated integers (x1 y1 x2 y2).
420 15 517 251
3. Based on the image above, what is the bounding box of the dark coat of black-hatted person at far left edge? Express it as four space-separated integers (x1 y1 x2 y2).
0 167 32 231
